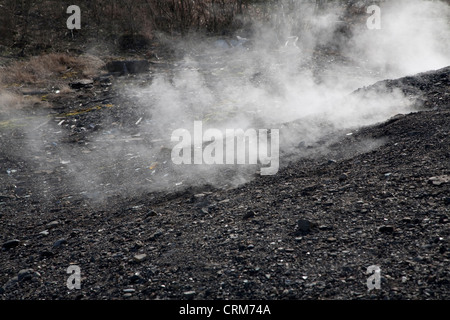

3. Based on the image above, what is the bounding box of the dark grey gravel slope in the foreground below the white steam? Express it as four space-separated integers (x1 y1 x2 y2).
0 67 450 300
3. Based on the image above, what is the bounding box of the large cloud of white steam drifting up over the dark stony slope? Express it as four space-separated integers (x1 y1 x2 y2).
2 0 450 200
